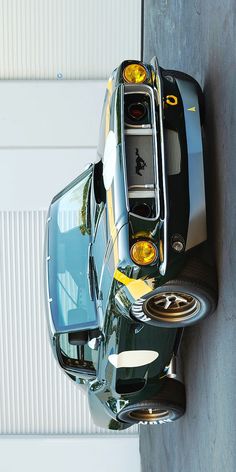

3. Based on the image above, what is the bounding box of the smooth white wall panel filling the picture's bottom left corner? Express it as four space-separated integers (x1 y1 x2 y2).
0 435 141 472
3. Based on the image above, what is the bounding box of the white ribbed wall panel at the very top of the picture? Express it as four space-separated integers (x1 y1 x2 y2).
0 0 141 79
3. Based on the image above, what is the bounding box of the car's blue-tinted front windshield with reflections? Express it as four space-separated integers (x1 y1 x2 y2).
48 170 97 332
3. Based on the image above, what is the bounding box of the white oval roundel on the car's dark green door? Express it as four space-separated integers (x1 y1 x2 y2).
108 350 159 369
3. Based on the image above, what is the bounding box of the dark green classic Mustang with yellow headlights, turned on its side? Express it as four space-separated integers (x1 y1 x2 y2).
46 58 216 430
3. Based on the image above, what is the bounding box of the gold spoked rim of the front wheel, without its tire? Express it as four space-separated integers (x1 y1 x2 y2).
144 292 200 321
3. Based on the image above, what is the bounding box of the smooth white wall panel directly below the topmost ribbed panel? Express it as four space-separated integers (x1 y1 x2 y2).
0 80 106 148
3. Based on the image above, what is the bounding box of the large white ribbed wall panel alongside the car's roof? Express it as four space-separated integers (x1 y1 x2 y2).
0 211 137 434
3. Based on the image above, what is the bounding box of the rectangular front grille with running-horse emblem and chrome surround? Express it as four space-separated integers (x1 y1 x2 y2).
124 85 159 219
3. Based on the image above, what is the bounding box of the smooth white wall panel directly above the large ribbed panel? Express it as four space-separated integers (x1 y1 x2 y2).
0 147 96 211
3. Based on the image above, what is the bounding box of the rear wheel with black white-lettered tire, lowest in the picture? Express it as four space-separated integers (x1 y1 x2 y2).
117 378 186 424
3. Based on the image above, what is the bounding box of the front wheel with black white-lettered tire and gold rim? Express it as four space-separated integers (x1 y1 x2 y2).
131 259 217 328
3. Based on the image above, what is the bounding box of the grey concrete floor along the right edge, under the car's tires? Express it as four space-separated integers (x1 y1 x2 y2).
140 0 236 472
